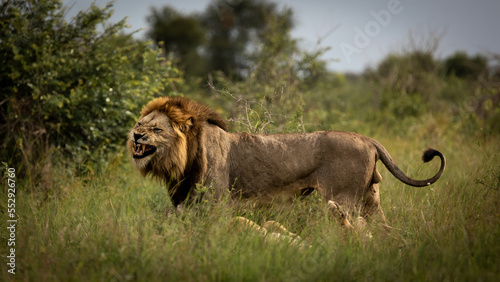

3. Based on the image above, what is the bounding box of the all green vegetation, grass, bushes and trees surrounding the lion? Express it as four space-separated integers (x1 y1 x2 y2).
0 0 500 281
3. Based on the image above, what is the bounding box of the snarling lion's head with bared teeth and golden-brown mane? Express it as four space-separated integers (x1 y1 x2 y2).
127 97 226 181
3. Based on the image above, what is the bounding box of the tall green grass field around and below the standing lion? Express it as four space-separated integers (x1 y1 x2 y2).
0 116 500 281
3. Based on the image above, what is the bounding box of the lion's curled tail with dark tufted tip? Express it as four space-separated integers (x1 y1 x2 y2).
372 139 446 187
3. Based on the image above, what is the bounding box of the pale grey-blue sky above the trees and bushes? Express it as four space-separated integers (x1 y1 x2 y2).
63 0 500 72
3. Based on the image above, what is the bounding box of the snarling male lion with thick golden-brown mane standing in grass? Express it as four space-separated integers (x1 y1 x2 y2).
127 97 445 227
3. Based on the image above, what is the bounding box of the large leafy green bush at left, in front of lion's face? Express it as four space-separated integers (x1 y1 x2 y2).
0 0 182 181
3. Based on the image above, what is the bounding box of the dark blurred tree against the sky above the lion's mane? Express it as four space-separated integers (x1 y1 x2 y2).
148 0 293 80
